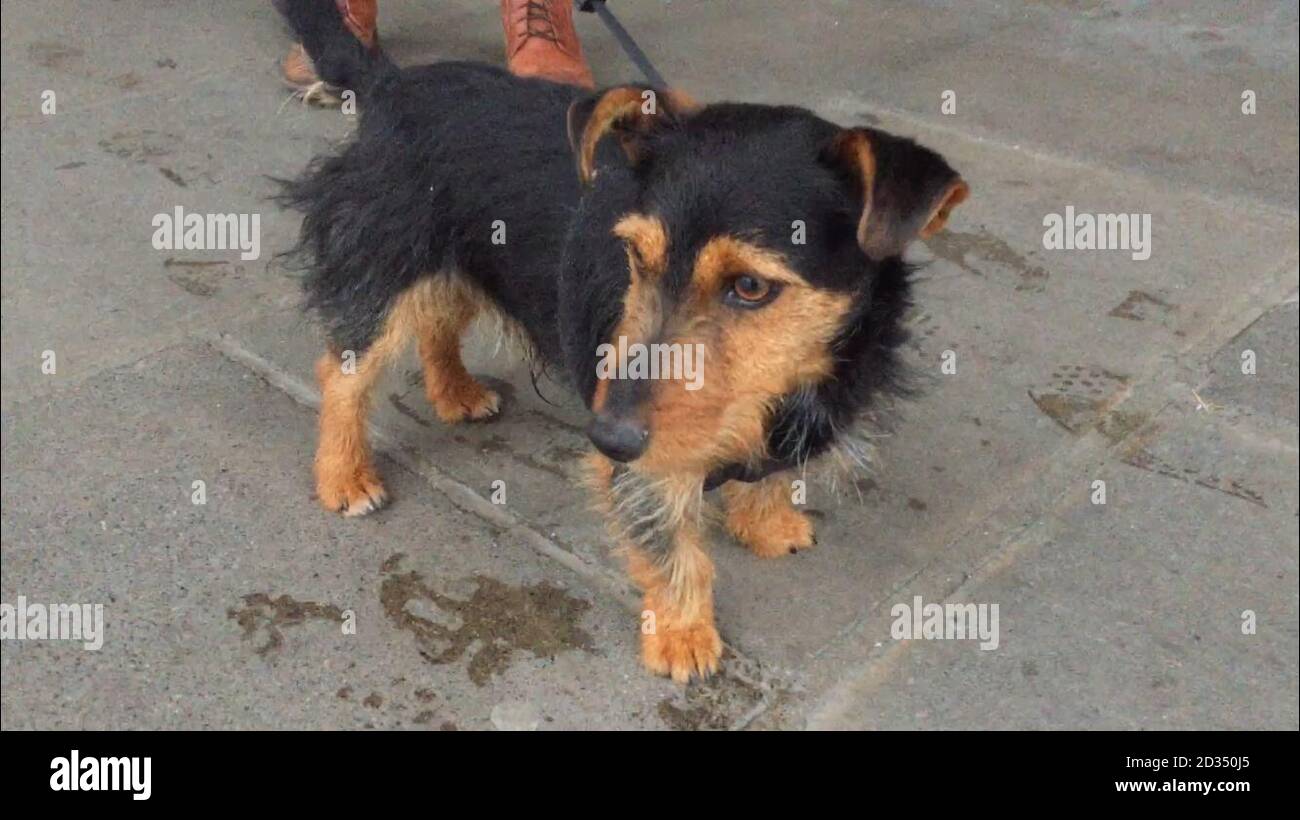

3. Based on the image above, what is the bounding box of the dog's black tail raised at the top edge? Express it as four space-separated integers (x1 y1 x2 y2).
276 0 398 99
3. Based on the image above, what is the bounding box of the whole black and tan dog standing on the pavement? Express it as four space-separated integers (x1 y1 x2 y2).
281 0 969 680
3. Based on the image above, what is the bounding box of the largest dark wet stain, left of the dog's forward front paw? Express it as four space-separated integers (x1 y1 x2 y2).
380 559 594 686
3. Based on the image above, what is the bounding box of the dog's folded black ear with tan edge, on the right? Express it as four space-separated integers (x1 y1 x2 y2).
824 129 970 261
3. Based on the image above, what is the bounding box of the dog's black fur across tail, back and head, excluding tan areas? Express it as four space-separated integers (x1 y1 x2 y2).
280 0 956 483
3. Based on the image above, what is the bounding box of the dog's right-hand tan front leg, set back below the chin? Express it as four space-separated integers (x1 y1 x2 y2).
723 470 816 557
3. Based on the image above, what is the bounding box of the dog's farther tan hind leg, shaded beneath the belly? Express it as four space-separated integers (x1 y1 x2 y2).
417 274 501 424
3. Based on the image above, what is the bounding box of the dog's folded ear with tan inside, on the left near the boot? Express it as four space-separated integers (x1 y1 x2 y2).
568 86 698 183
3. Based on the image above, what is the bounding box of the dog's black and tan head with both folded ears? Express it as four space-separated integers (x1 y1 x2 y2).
560 86 969 476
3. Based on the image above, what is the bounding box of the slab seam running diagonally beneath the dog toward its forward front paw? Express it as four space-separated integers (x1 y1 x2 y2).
195 327 787 730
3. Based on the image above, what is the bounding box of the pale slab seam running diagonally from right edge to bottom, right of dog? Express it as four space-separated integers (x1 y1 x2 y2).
805 260 1300 729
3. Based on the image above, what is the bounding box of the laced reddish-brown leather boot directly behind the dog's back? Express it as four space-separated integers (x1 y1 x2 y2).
501 0 595 88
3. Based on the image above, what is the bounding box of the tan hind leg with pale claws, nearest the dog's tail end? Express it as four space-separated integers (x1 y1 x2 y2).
315 283 429 516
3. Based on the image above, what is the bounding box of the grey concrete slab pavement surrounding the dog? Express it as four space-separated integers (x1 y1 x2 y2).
0 0 1300 729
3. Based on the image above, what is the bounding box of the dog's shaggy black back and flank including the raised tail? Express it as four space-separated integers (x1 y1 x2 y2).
281 0 582 359
